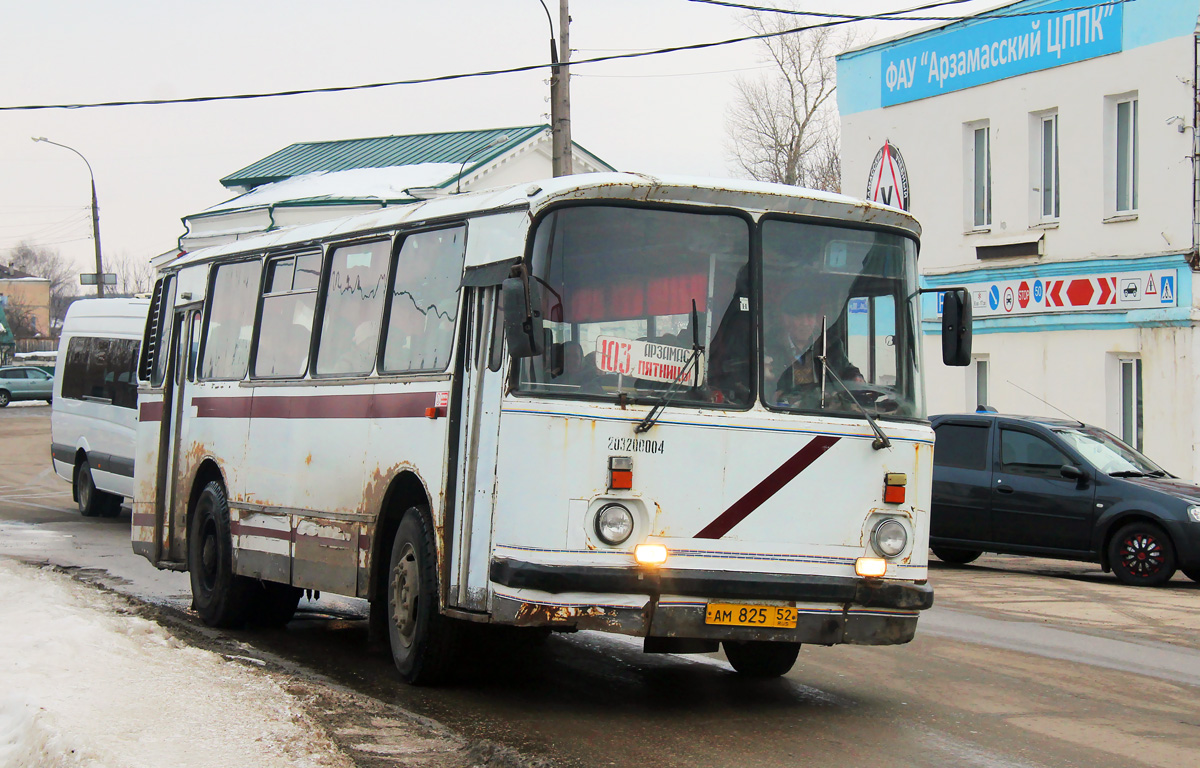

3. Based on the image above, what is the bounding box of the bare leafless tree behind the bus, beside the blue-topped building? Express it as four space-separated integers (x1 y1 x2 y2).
726 12 853 192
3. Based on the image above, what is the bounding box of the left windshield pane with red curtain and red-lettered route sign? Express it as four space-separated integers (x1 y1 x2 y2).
521 205 752 407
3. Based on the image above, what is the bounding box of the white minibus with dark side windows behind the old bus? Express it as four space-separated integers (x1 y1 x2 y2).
50 299 150 517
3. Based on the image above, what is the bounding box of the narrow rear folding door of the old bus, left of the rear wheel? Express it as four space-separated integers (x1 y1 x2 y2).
155 306 200 563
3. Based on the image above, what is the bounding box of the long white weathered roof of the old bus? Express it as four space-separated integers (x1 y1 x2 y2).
157 173 920 269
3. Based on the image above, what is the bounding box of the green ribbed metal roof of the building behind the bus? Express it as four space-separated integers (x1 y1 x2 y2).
221 125 550 190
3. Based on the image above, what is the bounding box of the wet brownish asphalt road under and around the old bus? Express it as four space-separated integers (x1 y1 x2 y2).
0 406 1200 768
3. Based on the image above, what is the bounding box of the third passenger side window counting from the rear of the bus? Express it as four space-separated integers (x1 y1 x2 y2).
317 240 391 376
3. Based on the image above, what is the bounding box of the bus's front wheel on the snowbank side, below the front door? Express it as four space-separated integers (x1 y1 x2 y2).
388 506 462 685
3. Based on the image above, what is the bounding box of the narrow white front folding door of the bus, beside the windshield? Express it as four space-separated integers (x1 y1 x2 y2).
448 286 504 611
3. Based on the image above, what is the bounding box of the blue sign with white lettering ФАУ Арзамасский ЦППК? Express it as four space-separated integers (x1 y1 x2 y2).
880 0 1124 107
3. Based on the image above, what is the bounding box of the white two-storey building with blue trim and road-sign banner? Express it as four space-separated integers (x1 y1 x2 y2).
838 0 1200 480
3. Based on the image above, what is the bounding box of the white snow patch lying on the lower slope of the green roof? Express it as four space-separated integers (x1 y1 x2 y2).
198 163 461 216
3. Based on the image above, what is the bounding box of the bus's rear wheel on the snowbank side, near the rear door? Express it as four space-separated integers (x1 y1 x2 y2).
187 480 257 628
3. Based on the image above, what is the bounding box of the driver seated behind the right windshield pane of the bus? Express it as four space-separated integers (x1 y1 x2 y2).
768 283 863 408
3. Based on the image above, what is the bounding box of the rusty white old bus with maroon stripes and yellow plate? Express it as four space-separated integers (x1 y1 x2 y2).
132 174 970 683
